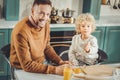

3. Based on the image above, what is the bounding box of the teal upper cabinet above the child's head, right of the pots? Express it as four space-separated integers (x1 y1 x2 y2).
83 0 101 19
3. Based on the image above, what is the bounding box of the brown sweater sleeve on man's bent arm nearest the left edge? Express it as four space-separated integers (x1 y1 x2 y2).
13 34 56 74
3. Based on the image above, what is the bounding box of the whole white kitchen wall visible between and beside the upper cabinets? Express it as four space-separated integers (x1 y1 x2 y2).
0 0 120 19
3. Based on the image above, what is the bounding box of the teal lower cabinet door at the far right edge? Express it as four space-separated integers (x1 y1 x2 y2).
104 26 120 63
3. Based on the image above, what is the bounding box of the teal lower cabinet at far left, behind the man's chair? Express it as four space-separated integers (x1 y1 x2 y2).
0 29 8 80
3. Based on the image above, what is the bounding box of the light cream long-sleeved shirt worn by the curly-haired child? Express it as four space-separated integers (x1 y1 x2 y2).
69 34 98 63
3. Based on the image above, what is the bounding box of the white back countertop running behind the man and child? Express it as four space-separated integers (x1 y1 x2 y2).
0 16 120 29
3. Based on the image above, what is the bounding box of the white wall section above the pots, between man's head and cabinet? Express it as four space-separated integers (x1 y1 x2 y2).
51 0 83 17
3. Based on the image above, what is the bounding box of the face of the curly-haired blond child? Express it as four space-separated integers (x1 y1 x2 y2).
79 21 92 35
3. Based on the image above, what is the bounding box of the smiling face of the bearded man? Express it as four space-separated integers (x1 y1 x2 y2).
32 4 51 27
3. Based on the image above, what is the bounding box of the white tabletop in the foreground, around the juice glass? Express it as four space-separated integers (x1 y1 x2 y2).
15 63 120 80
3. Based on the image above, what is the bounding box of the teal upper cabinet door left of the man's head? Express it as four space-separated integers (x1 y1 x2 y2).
4 0 19 20
